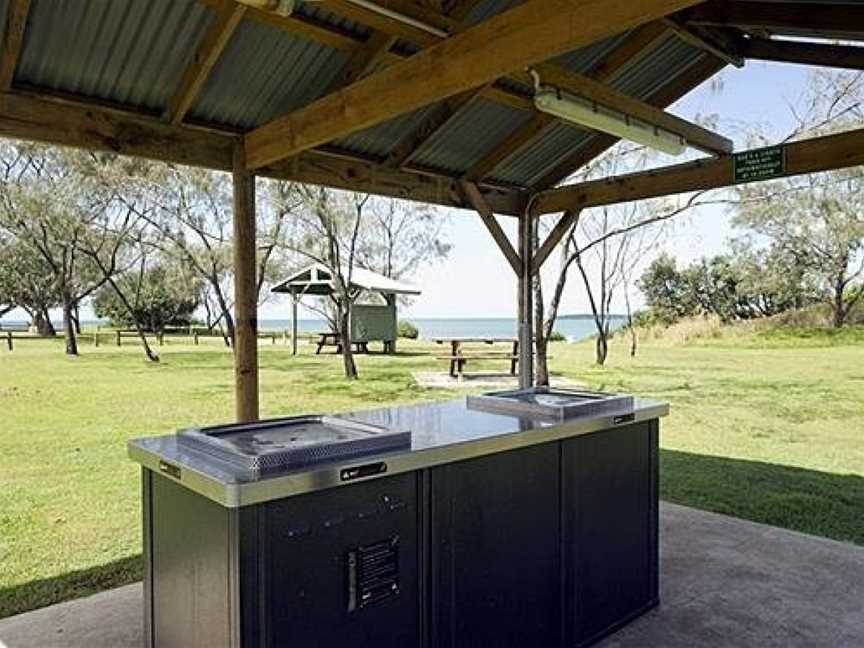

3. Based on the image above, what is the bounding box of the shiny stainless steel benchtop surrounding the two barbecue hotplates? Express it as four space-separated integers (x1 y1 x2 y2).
128 398 669 508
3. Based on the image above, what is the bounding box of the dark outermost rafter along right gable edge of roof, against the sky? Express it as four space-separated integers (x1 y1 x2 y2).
532 55 726 191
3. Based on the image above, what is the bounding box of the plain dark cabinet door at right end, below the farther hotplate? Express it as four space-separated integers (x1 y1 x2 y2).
562 423 658 645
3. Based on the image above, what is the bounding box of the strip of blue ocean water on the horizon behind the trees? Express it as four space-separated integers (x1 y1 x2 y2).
0 315 625 341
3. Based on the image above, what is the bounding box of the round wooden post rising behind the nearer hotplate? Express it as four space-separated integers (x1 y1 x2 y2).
234 142 258 422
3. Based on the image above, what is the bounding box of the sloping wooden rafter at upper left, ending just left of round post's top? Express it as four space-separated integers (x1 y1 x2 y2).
163 0 248 124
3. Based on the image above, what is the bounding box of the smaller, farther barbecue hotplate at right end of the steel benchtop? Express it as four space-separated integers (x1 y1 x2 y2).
467 387 635 420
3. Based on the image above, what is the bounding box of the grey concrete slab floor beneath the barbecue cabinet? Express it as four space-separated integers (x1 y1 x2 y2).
0 504 864 648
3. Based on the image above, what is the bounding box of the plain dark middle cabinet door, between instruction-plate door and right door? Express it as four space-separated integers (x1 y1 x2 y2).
431 444 561 648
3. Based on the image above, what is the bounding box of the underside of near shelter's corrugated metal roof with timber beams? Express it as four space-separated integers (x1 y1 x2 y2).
0 0 864 214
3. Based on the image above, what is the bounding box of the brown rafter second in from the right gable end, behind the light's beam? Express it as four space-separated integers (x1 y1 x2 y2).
456 21 667 181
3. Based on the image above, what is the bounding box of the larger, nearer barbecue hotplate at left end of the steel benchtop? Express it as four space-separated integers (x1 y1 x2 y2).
177 416 411 476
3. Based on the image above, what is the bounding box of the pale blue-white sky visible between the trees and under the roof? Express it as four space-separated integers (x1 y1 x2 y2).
6 62 808 320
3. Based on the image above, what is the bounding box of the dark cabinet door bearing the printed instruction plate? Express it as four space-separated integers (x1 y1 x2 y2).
250 474 421 648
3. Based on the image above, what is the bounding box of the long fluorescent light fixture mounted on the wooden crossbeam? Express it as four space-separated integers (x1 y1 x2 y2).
534 86 687 156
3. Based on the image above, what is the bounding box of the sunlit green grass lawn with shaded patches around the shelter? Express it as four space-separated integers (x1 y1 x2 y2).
0 332 864 617
